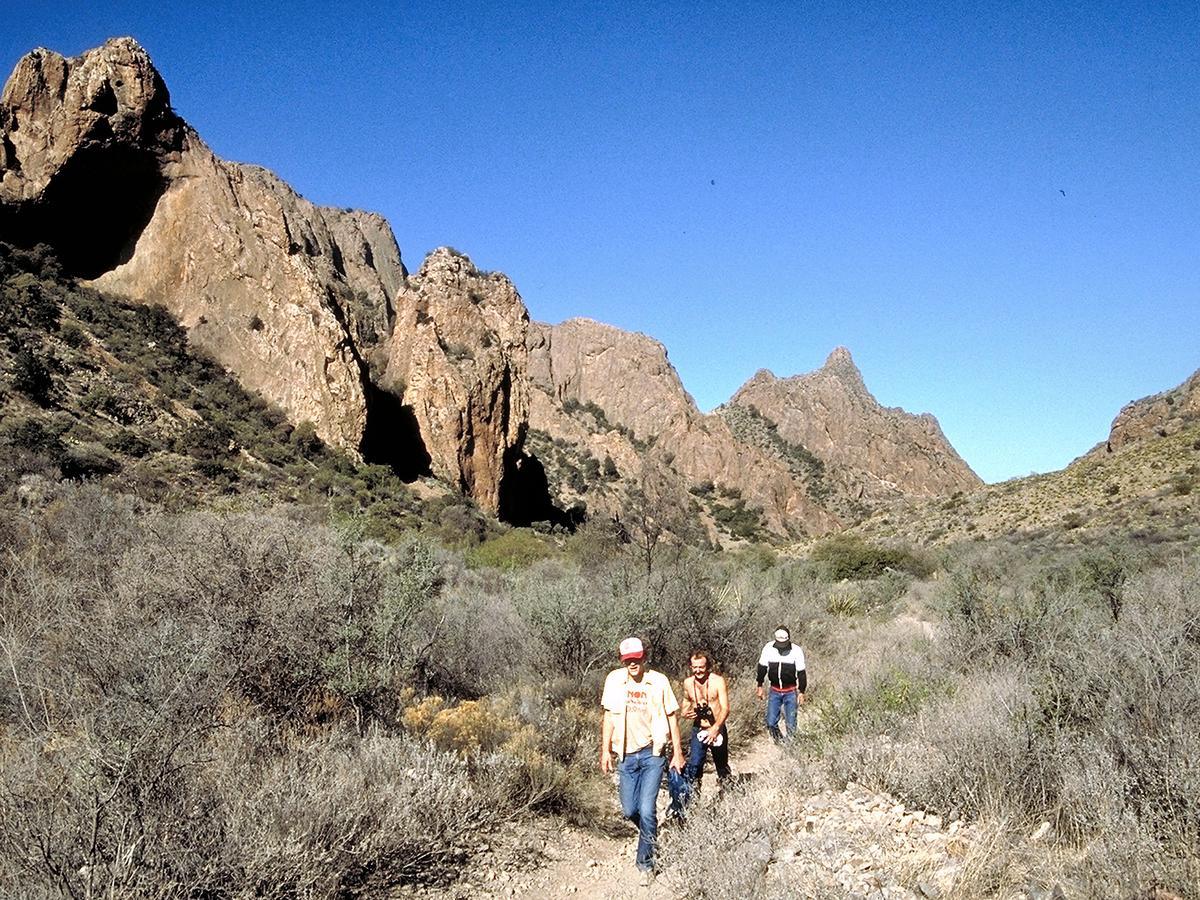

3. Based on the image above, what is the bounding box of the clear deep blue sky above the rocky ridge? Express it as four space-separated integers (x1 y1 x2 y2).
0 0 1200 481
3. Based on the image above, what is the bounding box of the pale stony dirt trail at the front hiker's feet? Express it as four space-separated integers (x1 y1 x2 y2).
419 734 1008 900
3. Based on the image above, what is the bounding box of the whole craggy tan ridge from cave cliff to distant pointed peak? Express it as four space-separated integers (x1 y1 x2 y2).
0 38 978 539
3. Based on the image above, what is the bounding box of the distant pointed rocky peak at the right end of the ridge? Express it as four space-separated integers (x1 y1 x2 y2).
730 347 983 503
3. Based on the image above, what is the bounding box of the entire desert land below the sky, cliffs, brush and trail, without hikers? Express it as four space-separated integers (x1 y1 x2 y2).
0 38 1200 900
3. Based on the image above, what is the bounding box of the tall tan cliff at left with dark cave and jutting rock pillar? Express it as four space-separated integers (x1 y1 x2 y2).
0 38 527 511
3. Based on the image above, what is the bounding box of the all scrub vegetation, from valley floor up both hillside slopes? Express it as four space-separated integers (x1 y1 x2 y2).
0 241 1200 898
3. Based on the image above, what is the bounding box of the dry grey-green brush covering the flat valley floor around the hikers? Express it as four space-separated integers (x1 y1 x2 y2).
0 485 1200 896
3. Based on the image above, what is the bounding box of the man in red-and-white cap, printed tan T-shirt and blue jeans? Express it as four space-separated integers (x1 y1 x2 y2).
600 637 684 883
